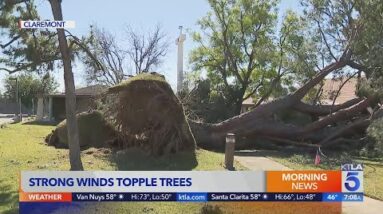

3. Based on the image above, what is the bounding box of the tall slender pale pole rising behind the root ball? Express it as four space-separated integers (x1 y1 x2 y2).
176 26 186 93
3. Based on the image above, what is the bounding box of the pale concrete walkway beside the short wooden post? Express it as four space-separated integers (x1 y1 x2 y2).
235 150 383 214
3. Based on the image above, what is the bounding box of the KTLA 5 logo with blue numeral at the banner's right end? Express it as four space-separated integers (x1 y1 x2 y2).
342 164 363 192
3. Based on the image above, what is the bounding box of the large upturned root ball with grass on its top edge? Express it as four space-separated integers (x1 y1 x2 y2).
109 73 196 155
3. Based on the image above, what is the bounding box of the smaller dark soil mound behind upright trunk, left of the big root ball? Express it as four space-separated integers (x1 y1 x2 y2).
45 111 117 148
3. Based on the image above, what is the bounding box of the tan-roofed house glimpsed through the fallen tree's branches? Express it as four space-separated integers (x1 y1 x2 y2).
241 78 358 113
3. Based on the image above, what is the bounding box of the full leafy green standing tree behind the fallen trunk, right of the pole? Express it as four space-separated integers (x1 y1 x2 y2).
190 0 315 118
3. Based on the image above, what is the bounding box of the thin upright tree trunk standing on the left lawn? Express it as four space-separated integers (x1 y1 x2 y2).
49 0 84 170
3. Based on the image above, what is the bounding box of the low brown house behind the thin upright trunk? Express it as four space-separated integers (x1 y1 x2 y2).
37 85 107 122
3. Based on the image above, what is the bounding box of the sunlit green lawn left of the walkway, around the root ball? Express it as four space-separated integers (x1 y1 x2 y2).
0 124 244 213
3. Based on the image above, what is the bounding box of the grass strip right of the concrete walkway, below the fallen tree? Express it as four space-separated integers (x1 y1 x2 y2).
265 150 383 200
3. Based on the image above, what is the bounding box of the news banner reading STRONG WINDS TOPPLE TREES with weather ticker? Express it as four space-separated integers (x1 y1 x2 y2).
19 164 363 212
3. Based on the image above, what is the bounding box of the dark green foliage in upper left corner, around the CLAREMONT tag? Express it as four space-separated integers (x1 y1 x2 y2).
0 0 60 73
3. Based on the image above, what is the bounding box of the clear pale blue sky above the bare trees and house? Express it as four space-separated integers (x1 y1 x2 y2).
3 0 299 91
